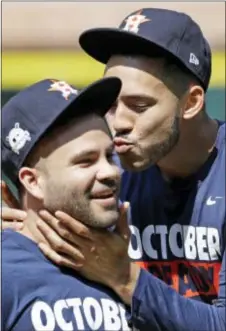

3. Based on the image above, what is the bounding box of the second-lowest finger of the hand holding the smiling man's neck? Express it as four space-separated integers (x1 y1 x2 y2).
37 220 84 265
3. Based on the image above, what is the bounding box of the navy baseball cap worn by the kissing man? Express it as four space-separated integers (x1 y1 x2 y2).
79 8 211 90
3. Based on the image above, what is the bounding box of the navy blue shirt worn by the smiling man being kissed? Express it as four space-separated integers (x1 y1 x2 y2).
2 230 129 331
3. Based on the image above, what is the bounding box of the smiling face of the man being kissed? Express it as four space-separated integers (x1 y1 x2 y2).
20 115 120 228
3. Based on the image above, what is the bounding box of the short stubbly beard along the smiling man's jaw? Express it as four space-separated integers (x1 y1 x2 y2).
41 182 119 228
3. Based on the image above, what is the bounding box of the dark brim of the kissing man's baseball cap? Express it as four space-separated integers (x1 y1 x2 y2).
79 28 177 64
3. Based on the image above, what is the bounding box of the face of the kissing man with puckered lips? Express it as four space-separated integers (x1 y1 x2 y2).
105 56 183 171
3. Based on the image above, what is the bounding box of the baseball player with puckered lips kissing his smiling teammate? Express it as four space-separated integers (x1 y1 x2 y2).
1 8 226 331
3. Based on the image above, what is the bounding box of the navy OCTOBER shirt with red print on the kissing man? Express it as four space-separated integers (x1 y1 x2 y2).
121 124 226 331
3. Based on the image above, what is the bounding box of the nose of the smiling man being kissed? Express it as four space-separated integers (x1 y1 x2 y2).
96 160 120 185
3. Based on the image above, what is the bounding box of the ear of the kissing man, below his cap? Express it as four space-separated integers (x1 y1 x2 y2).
183 85 205 120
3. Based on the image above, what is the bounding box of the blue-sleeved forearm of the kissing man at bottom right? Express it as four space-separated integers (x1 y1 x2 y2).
115 270 226 331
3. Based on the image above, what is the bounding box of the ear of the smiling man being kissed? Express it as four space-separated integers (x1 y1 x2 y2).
19 167 44 200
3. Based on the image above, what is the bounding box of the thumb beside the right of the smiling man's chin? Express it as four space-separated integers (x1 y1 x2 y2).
115 201 130 243
